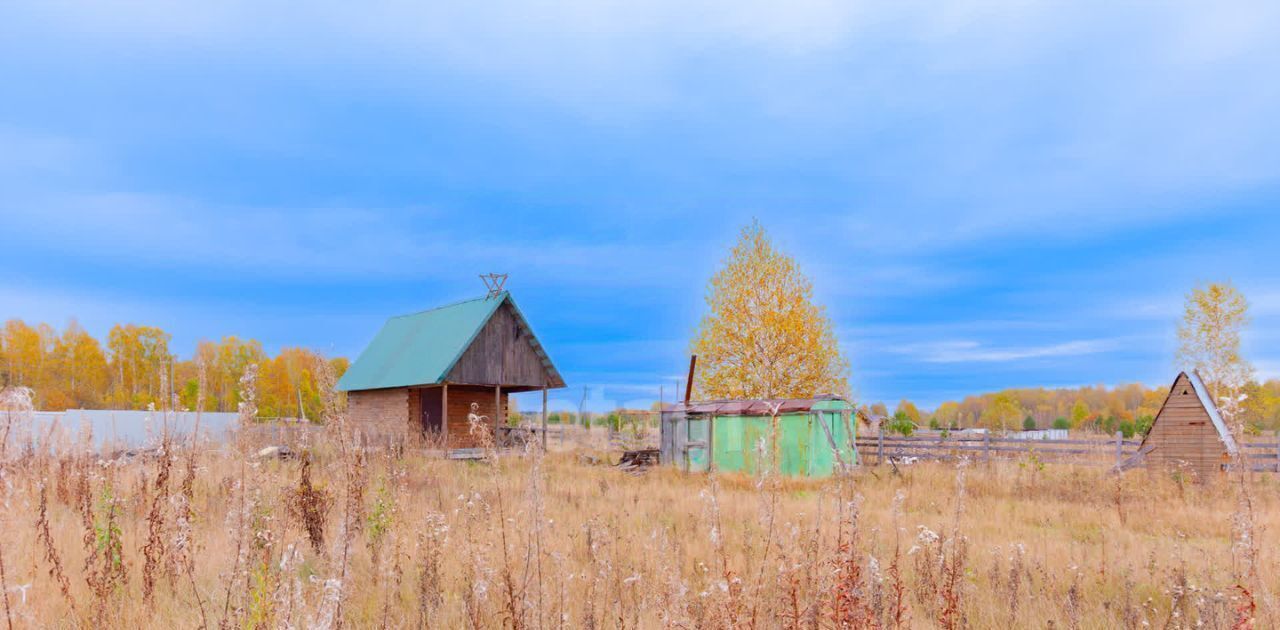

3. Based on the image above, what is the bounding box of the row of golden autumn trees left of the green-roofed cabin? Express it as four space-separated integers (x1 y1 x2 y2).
0 319 348 420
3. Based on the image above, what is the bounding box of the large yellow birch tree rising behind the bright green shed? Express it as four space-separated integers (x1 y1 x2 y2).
690 223 849 400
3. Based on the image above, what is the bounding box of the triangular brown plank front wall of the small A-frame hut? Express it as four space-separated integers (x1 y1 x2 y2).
1146 374 1228 478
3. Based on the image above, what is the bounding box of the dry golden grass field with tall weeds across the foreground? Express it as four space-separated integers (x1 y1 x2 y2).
0 412 1280 629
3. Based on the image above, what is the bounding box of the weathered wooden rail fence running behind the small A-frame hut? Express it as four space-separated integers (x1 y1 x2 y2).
856 432 1280 473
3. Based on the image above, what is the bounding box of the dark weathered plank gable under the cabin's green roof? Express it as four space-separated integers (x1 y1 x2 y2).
445 302 554 389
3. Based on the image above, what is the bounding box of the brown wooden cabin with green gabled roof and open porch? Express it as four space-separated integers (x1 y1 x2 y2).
338 292 564 448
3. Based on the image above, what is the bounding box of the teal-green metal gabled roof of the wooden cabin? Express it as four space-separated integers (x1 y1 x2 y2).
338 292 563 392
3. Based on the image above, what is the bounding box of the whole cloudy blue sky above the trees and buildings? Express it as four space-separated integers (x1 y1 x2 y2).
0 0 1280 407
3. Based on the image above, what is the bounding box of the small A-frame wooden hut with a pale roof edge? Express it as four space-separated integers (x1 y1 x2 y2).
1138 371 1236 479
